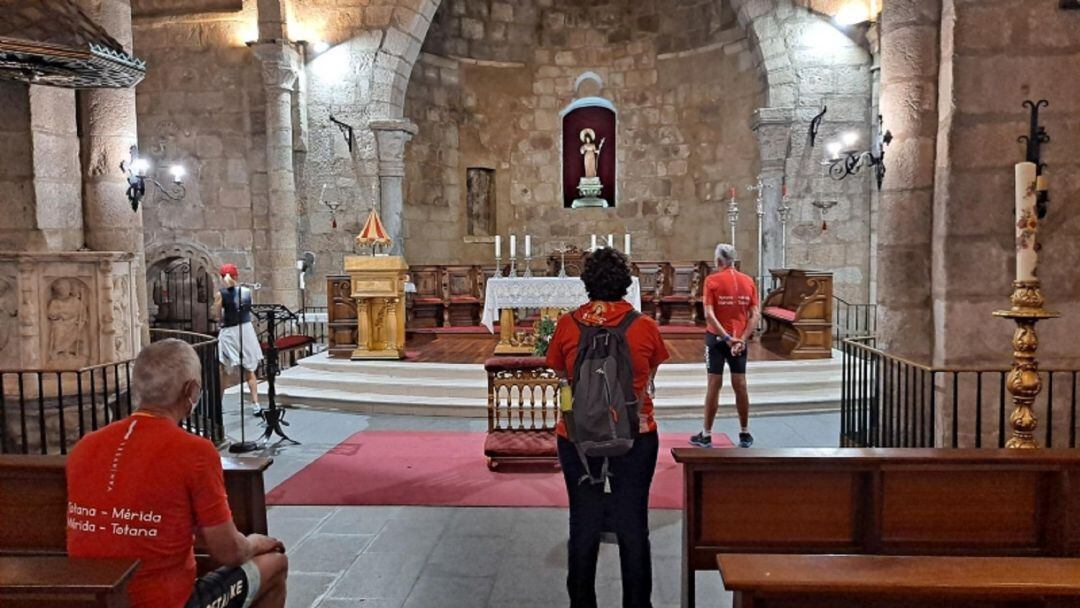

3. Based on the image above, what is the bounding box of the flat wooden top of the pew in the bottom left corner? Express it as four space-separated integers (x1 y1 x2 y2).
0 555 138 593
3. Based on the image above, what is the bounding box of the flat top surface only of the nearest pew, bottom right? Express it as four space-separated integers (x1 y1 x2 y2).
716 554 1080 598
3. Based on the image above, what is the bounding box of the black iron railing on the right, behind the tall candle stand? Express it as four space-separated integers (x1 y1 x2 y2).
840 337 1080 447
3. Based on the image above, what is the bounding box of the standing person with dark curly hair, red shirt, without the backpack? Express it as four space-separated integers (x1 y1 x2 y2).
548 248 669 608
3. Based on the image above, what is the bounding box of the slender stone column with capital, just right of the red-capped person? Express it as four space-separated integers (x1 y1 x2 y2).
254 42 300 308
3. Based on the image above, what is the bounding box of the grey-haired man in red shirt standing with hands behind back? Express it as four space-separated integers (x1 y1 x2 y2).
690 243 759 447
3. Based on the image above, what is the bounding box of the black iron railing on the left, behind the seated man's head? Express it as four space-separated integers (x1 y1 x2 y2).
0 329 225 454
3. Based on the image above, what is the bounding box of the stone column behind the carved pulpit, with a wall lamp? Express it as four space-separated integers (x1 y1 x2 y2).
79 0 150 351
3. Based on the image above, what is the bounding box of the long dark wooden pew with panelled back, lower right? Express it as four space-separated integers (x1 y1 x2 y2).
672 448 1080 607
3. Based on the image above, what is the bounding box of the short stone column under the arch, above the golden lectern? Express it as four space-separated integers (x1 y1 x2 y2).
368 119 417 256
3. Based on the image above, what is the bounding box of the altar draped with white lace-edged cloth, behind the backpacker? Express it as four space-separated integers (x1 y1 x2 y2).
481 276 642 355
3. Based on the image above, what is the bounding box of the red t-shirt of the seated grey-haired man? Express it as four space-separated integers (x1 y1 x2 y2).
67 413 232 608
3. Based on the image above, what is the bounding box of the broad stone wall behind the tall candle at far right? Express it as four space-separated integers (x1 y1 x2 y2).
933 0 1080 365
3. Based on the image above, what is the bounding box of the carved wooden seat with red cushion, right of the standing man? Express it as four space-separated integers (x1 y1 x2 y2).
761 269 833 359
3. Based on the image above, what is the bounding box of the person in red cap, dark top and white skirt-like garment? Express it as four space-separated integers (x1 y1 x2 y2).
213 264 262 408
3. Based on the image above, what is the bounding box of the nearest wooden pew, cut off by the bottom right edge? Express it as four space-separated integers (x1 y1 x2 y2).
716 554 1080 608
